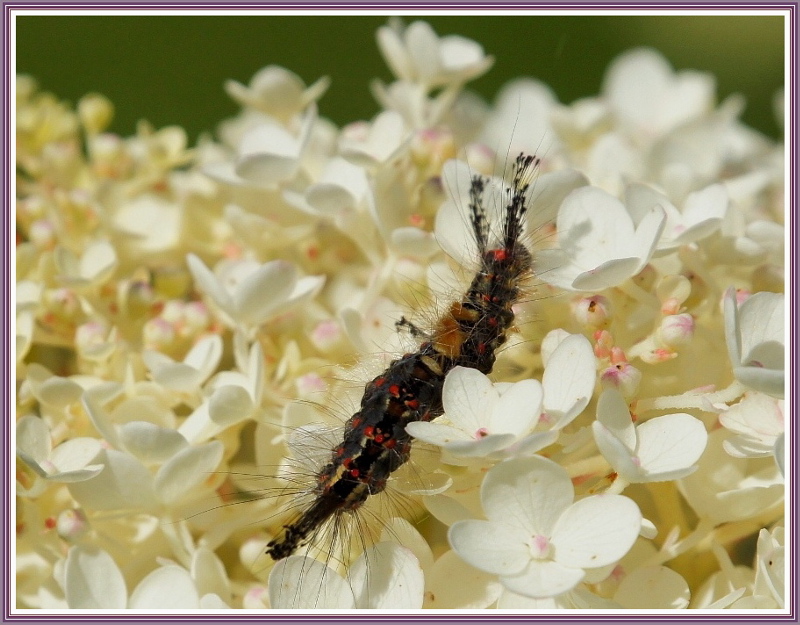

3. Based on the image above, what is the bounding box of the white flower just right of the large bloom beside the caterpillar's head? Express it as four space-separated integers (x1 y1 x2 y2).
625 183 728 252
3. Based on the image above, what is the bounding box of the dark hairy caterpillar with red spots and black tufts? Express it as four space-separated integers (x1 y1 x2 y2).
266 154 539 561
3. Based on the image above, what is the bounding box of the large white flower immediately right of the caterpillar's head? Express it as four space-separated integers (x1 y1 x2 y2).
536 187 666 291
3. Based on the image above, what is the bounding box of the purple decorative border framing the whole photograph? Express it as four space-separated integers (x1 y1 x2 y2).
0 0 800 625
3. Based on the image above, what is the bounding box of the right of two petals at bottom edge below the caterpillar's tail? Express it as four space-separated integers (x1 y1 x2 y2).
347 542 425 610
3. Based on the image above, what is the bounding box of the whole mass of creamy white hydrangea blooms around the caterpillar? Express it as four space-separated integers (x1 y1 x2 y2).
16 21 785 610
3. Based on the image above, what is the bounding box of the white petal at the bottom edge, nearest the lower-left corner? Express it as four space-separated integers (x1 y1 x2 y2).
64 545 128 610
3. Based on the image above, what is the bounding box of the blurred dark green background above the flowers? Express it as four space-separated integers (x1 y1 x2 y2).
16 13 784 141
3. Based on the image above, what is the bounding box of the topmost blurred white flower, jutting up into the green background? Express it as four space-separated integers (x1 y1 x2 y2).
377 21 494 88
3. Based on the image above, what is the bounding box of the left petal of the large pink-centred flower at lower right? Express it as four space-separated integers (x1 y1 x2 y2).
447 520 530 575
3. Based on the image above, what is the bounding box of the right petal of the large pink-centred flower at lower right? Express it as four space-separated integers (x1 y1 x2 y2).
551 495 642 568
